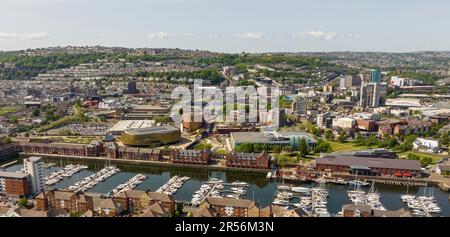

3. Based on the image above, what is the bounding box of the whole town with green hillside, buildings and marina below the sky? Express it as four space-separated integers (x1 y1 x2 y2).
0 46 450 217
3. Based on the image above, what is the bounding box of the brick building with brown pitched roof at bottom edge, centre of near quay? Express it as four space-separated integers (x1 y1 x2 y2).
200 197 260 217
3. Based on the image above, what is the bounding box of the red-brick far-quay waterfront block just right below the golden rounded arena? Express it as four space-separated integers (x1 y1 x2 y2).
170 149 213 165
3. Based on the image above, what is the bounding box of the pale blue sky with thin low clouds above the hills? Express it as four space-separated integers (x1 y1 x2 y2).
0 0 450 53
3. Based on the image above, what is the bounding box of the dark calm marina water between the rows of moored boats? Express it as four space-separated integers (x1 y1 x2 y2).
6 158 450 217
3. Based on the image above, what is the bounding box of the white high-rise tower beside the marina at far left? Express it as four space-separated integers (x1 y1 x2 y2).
23 156 44 194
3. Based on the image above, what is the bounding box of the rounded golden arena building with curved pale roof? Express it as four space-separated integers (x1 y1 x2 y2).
121 126 181 147
